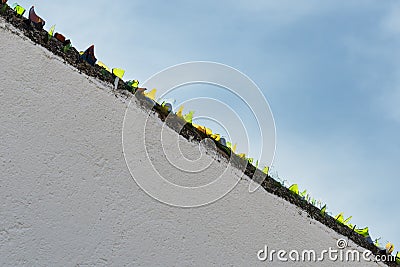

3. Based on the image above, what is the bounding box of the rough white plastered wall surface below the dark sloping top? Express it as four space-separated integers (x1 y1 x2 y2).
0 19 388 266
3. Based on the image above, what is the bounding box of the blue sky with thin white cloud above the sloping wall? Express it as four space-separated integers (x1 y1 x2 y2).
16 0 400 250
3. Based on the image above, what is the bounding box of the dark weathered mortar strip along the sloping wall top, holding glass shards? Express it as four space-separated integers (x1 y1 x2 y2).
0 4 398 266
